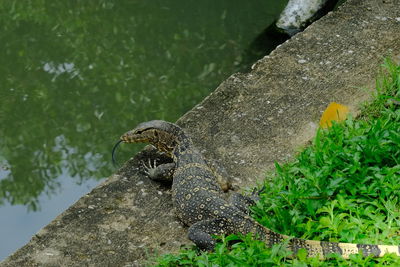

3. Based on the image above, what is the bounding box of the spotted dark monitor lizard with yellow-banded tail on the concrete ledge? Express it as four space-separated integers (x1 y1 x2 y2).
116 120 400 259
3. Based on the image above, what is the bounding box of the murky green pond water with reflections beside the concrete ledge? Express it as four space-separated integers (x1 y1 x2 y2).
0 0 286 259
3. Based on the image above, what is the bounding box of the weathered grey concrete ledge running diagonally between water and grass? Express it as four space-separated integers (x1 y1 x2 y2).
0 0 400 266
